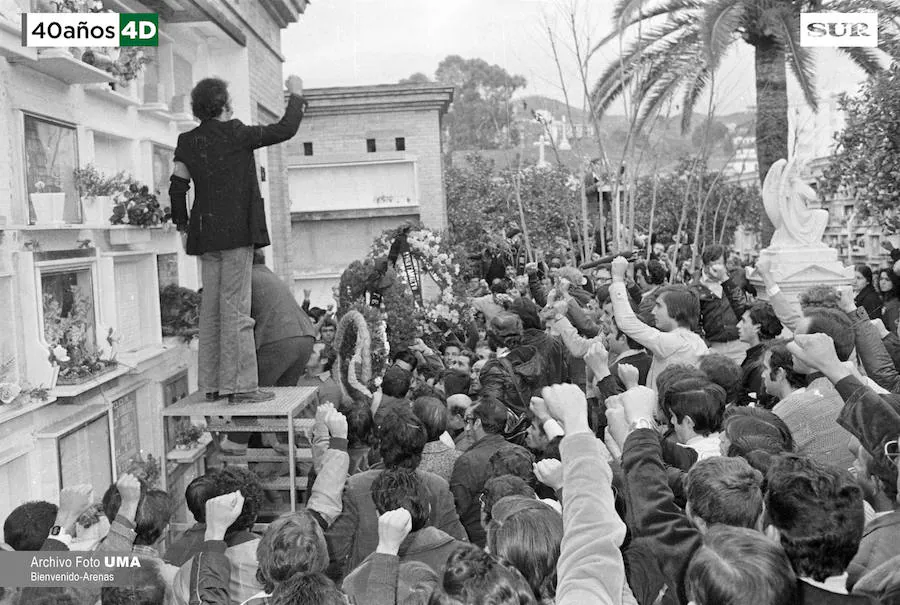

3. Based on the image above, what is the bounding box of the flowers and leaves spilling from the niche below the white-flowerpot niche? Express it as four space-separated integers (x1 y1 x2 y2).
44 286 118 384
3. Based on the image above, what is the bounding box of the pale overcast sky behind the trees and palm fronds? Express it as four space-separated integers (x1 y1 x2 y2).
282 0 862 115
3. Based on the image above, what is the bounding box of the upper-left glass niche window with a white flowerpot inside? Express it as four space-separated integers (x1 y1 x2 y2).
25 114 81 225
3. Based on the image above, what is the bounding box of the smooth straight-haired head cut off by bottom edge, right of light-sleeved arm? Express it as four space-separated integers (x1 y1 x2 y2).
685 525 797 605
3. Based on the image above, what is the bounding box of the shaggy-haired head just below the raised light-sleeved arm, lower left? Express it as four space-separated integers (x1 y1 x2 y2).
256 509 328 593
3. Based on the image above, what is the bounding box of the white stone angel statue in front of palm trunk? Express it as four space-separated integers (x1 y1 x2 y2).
762 159 828 248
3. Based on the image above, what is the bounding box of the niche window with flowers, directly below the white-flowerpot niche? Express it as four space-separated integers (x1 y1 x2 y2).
41 267 97 365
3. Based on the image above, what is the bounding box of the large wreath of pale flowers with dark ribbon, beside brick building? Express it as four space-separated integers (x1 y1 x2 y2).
372 222 472 330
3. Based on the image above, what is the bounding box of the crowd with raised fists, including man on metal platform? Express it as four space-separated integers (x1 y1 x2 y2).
0 80 900 605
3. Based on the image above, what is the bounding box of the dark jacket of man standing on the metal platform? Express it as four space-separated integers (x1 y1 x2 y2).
172 95 306 255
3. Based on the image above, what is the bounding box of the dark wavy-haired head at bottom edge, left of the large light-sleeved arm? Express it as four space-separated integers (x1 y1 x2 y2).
428 544 537 605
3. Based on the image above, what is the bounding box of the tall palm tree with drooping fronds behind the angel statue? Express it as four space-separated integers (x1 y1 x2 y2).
592 0 900 245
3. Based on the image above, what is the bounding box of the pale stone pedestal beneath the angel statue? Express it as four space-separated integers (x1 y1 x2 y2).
750 244 855 303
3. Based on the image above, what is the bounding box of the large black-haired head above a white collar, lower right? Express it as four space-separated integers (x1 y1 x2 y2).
766 454 865 582
